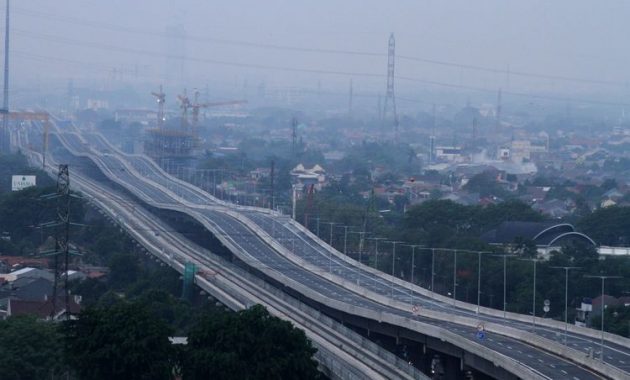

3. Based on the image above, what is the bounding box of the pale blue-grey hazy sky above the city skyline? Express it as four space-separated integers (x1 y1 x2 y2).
11 0 630 101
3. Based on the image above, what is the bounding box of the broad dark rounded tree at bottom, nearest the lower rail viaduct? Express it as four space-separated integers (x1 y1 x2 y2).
183 305 319 380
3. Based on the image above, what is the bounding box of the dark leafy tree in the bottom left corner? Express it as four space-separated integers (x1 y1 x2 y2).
0 317 63 380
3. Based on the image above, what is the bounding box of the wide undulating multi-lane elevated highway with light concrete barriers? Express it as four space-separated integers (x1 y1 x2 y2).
17 118 630 379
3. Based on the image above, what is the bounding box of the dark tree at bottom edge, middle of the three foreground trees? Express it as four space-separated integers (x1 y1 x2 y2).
64 302 174 380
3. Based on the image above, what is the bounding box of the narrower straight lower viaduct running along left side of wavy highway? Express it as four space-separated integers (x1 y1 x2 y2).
22 130 428 380
